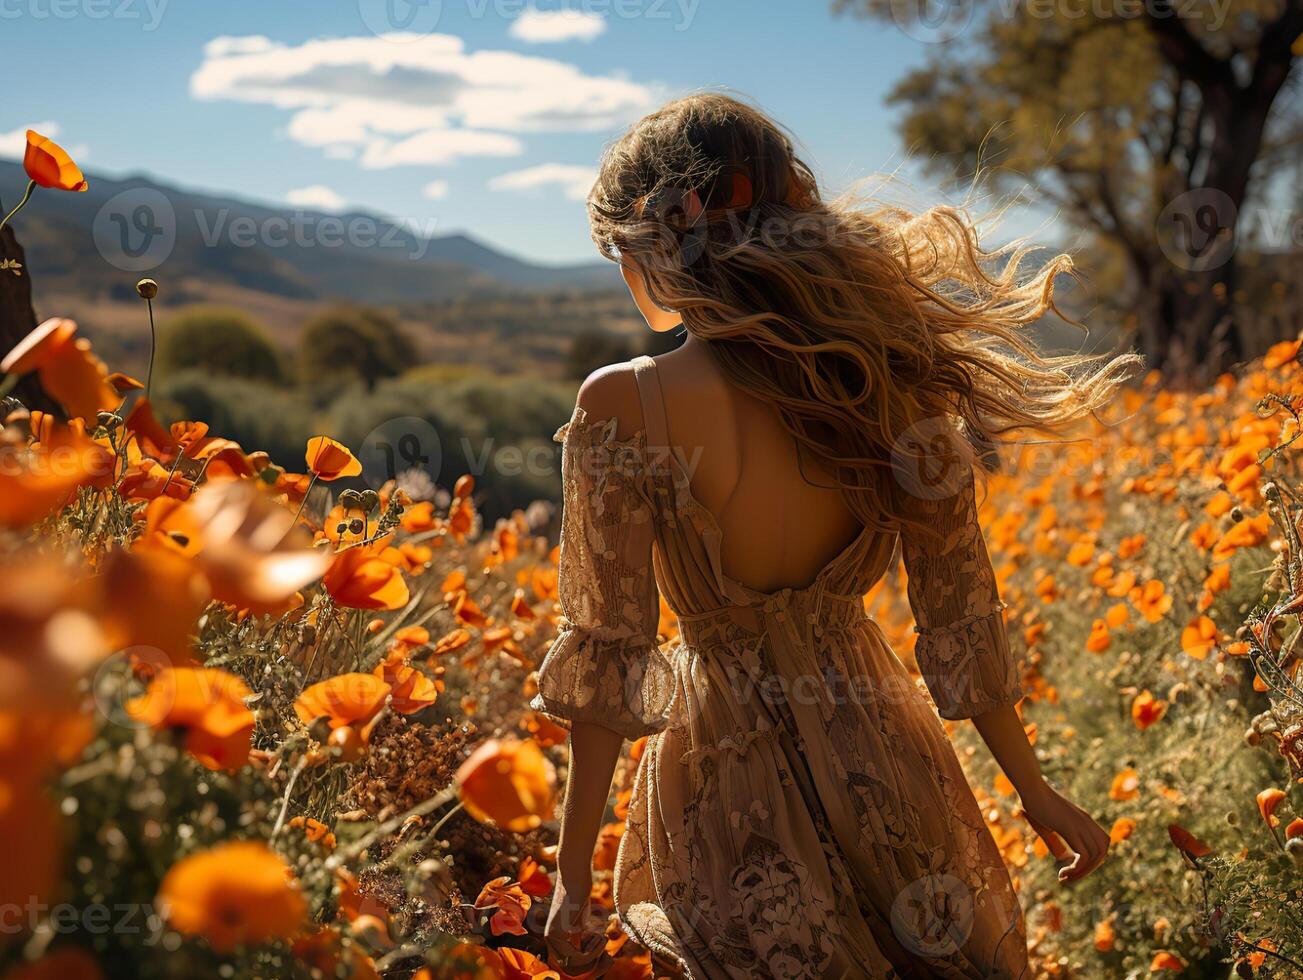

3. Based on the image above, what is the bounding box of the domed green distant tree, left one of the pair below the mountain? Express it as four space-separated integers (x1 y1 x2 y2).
158 306 283 382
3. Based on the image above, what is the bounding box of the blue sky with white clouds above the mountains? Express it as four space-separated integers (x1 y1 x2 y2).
0 0 959 262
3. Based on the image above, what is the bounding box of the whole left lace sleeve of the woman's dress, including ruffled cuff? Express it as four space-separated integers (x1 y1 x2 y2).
530 408 674 739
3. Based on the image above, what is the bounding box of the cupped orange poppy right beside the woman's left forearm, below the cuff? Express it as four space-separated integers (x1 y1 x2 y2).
456 739 556 833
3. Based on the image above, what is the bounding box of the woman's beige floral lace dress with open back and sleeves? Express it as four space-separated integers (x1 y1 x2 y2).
533 358 1028 980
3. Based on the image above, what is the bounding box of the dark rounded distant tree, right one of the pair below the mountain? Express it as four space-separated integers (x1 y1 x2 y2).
298 305 418 391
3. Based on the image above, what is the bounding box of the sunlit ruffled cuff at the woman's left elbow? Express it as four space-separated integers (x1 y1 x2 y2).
529 627 674 739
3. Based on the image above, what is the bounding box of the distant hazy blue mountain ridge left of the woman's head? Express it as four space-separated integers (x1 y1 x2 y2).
0 160 614 305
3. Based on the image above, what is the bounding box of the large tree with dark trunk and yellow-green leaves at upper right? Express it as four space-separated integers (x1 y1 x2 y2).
835 0 1303 368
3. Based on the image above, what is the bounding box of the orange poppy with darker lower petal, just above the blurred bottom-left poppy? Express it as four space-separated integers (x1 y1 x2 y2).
126 667 254 771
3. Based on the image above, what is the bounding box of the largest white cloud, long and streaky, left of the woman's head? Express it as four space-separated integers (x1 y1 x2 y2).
190 34 655 169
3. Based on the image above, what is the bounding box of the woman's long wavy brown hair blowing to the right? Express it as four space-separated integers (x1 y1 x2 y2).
588 94 1139 529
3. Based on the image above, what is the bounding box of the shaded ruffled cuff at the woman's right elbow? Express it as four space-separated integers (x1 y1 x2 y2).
915 603 1023 721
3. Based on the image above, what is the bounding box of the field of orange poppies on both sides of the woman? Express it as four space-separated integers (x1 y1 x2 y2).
0 132 1303 979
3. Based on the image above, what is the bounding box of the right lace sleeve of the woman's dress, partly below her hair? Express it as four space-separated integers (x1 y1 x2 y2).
902 464 1022 719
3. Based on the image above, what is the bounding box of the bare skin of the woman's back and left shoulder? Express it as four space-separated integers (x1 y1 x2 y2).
579 340 861 592
